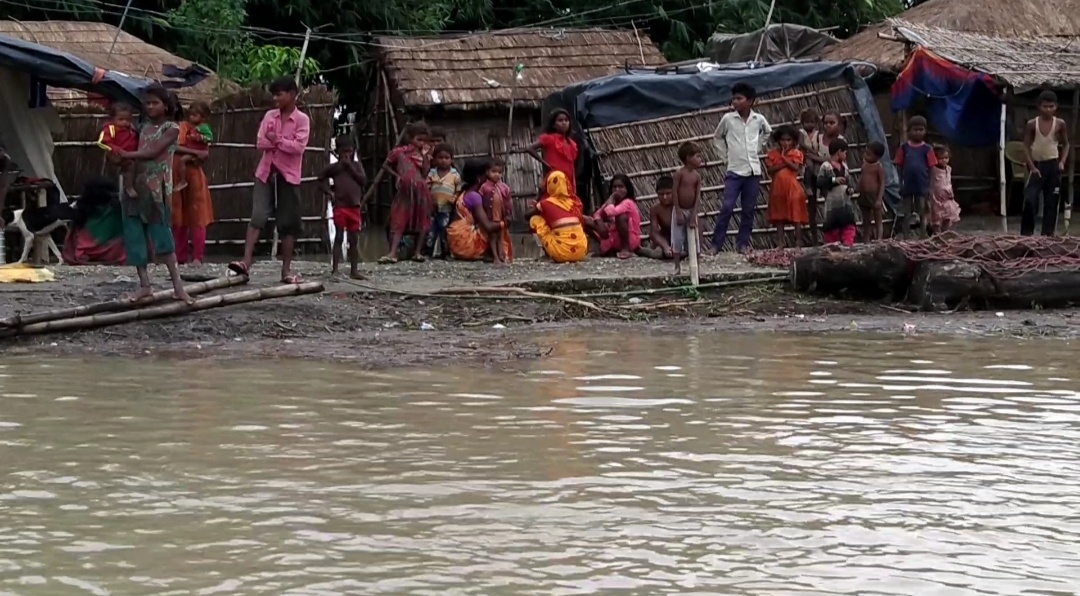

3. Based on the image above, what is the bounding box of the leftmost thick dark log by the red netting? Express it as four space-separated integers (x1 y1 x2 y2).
789 243 912 300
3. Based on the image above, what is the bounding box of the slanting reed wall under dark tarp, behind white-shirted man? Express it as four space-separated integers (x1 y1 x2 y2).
586 79 889 249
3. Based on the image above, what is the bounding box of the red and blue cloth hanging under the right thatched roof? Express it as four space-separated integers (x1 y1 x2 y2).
892 48 1001 147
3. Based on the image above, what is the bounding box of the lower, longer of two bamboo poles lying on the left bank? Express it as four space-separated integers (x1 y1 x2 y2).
0 282 323 337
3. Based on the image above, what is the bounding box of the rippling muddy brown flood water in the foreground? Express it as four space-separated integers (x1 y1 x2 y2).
0 334 1080 595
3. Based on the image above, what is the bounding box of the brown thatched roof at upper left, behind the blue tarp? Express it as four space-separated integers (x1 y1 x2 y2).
0 21 225 106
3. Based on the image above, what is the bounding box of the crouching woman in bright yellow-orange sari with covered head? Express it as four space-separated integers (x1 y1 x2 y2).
527 171 589 262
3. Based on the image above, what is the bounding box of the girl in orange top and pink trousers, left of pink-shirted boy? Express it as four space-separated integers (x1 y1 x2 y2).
171 101 214 265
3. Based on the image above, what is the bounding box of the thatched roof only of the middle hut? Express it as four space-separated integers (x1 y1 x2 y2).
378 29 666 110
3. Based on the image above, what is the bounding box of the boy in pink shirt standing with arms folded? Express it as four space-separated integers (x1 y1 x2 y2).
229 77 311 284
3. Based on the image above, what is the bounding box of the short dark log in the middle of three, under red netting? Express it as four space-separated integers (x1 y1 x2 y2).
907 261 995 311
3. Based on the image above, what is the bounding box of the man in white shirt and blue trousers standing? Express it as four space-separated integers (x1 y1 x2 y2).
713 83 772 253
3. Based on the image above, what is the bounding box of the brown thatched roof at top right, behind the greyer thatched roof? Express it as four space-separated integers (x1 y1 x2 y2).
822 0 1080 72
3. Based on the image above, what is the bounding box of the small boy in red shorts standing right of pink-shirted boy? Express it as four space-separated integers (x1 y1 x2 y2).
319 135 367 280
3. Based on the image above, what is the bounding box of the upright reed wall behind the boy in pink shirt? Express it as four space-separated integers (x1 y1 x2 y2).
53 87 336 255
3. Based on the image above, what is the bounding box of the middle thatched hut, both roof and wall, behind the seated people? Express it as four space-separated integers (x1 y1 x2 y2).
361 29 667 228
